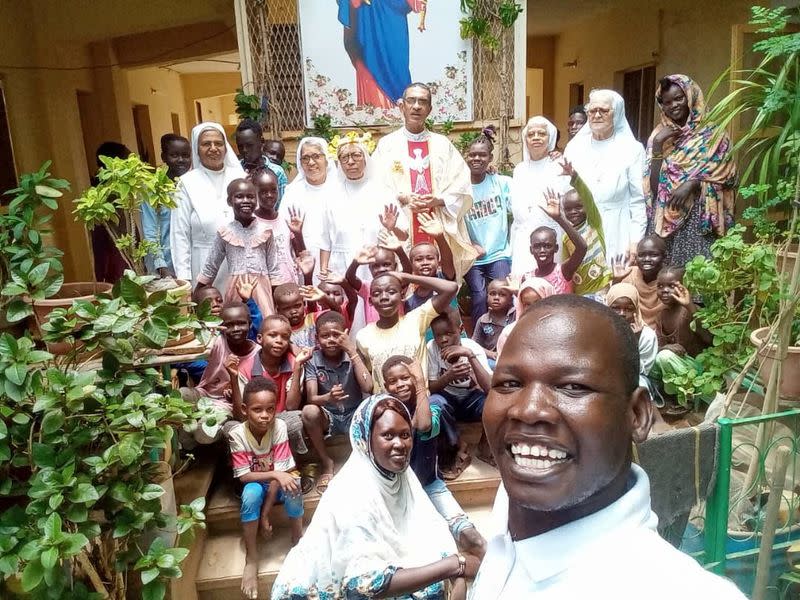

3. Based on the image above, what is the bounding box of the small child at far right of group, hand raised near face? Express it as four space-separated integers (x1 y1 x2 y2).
650 267 712 412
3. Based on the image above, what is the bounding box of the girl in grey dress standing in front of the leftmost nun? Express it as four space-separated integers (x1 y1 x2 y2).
197 179 281 315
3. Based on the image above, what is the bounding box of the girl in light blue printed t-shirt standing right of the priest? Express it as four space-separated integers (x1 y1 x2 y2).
464 127 511 323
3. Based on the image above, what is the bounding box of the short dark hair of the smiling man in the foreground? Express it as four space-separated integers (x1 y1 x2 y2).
526 294 639 394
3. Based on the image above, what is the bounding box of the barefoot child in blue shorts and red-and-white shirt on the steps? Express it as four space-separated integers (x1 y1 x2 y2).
228 377 303 598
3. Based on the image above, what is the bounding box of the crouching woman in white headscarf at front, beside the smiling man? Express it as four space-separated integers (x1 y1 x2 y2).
271 394 468 600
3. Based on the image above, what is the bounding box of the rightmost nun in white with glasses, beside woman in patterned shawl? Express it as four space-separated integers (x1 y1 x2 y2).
564 90 647 258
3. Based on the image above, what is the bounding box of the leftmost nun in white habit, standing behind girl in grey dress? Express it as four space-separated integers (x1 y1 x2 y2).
170 122 245 294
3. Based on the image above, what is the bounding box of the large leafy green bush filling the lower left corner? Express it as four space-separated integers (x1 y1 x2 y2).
0 271 216 600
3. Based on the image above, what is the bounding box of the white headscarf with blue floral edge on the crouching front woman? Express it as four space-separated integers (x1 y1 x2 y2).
272 394 456 600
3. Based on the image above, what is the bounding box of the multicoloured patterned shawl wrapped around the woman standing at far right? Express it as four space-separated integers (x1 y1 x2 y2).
644 74 737 237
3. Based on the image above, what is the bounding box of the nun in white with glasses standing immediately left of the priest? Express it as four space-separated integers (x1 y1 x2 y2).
279 137 341 283
